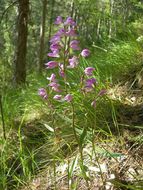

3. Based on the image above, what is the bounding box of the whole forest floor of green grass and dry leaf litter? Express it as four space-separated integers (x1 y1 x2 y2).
0 42 143 190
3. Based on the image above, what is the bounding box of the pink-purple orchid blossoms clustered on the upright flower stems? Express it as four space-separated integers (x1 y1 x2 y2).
39 16 106 107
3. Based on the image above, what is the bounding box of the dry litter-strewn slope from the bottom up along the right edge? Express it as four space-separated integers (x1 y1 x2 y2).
22 65 143 190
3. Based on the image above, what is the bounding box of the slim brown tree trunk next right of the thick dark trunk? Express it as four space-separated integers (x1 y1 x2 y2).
39 0 47 73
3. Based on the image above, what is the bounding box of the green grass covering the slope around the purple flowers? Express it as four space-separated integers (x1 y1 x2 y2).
0 39 140 190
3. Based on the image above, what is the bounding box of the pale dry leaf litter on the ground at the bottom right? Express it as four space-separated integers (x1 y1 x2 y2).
23 131 143 190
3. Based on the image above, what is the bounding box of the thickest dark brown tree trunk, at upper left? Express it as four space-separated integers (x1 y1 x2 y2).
14 0 29 85
